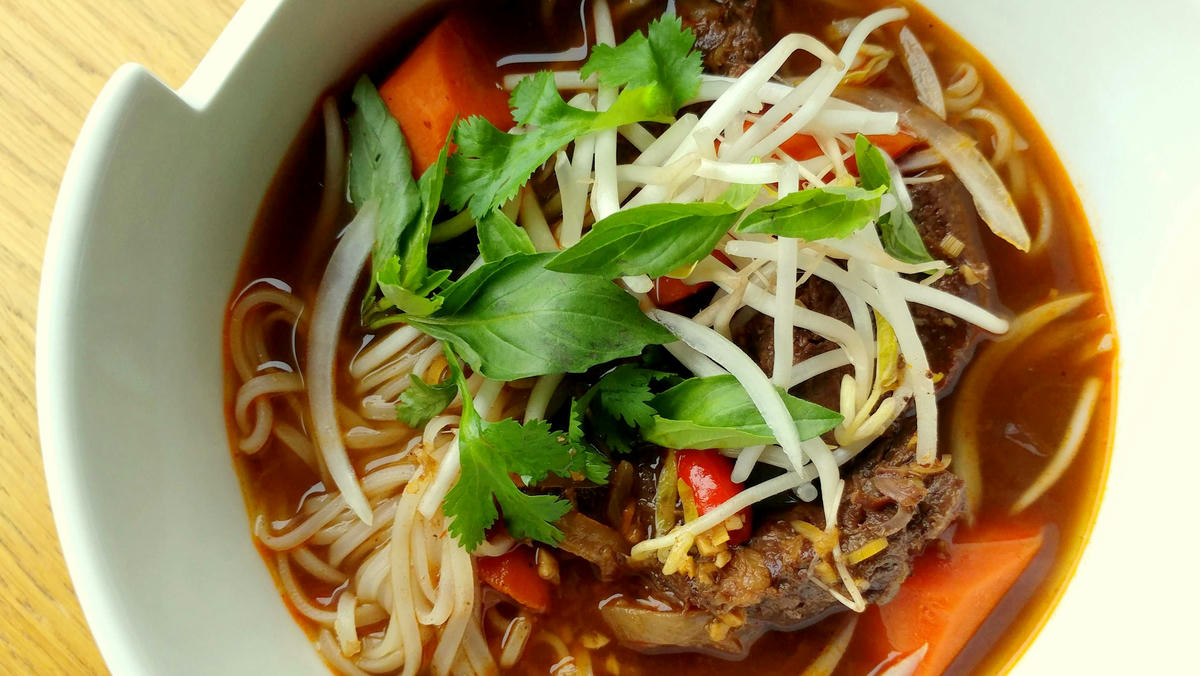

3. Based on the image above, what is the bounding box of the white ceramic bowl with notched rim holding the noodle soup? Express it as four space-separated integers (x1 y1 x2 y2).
37 0 1200 676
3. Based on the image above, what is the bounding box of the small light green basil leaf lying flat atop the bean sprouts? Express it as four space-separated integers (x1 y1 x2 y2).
738 186 883 241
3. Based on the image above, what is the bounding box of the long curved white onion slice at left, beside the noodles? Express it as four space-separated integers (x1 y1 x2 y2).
307 202 379 524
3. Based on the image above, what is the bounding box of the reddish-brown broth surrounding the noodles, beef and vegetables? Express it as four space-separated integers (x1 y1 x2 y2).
226 0 1116 676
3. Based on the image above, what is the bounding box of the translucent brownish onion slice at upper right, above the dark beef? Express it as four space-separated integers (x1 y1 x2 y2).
842 89 1030 251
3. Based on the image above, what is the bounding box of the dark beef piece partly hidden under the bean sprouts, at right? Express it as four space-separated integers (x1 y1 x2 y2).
734 169 998 409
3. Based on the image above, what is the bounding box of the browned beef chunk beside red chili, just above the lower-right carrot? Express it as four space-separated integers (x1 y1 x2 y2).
649 424 965 628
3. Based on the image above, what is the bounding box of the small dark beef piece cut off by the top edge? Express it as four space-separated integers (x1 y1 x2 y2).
676 0 766 77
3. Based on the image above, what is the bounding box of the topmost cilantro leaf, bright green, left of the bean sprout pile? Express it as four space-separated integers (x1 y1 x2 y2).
580 16 703 110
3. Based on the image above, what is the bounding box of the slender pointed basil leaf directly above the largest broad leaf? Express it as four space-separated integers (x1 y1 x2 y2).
546 202 740 279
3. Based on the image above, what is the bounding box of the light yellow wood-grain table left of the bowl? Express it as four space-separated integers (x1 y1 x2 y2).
0 0 238 676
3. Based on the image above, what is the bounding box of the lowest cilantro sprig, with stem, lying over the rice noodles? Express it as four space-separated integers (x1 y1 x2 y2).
442 346 607 551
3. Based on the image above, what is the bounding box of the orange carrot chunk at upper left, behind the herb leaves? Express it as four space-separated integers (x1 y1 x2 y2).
379 13 512 174
